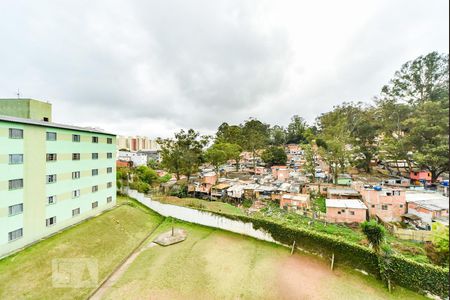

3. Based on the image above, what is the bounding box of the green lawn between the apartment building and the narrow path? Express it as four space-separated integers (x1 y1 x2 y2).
0 197 163 299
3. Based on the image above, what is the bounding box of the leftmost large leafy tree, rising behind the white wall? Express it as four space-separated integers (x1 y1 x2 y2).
157 129 209 180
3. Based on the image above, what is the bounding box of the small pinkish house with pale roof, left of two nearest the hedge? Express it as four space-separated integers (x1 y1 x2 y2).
326 199 367 223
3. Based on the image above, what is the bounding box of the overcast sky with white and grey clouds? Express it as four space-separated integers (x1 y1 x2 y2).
0 0 449 137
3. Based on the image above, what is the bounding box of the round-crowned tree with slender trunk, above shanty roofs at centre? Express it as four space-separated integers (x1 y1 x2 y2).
242 119 270 170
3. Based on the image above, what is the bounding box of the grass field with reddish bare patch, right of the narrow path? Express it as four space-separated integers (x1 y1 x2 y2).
105 220 424 299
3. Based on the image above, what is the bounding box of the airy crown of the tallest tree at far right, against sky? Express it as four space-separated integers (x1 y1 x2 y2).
382 52 449 105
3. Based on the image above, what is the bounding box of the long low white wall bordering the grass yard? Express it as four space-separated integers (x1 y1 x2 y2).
128 190 280 244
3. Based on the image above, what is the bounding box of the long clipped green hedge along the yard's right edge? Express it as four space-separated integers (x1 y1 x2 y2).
211 212 449 298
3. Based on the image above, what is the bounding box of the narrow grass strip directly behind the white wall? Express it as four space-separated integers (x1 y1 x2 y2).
152 196 244 215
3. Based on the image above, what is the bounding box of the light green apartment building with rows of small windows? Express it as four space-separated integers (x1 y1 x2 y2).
0 99 116 257
